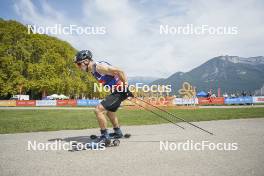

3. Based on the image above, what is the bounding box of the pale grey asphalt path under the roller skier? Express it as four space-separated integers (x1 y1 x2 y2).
0 118 264 176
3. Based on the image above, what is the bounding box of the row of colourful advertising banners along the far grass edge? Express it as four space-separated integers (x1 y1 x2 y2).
0 96 264 107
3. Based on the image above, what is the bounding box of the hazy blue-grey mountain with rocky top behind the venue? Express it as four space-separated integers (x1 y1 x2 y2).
150 55 264 94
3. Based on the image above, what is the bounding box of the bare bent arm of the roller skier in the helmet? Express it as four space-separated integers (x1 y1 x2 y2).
96 64 127 85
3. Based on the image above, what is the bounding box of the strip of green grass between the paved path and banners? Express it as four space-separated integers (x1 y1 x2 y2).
0 108 264 133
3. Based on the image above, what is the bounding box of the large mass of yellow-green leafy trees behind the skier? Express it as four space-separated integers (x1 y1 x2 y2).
0 19 106 99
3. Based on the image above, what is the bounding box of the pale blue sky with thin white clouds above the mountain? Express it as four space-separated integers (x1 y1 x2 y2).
0 0 264 77
